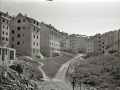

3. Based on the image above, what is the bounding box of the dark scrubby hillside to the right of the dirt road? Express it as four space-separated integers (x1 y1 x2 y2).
68 54 120 90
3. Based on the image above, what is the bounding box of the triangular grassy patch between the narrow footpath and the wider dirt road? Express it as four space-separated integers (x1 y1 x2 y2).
35 53 74 78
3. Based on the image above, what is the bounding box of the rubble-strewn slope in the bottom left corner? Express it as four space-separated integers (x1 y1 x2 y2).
0 66 38 90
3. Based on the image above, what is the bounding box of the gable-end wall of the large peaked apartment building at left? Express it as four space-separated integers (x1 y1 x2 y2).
9 25 32 56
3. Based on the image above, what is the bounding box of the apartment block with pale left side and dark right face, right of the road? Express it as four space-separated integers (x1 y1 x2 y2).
86 34 105 54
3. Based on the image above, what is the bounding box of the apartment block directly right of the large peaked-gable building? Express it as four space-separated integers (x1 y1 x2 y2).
40 22 61 56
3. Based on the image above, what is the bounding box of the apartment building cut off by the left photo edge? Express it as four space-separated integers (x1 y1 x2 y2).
0 12 13 43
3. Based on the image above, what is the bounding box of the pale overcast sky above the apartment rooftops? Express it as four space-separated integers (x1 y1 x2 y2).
0 0 120 36
